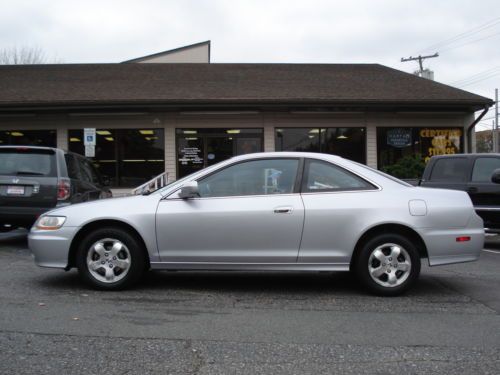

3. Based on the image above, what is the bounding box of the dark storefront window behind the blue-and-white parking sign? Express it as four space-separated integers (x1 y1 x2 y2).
68 129 165 187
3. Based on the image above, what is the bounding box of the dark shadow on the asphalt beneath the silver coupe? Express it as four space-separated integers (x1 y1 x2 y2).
38 270 442 299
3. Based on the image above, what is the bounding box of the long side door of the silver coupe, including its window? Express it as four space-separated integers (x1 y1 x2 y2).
156 158 304 263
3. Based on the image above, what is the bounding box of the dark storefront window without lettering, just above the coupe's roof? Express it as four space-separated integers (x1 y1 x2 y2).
275 128 366 163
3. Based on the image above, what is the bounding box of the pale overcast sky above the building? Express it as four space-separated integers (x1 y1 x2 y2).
0 0 500 130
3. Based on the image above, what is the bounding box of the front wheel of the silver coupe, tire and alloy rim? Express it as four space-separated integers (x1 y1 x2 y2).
76 227 147 290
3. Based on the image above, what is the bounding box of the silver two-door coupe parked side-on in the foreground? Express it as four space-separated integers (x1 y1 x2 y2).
29 152 484 295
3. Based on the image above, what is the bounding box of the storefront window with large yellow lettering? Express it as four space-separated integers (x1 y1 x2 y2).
377 128 463 169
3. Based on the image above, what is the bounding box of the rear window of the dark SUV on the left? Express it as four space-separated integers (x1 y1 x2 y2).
0 148 56 177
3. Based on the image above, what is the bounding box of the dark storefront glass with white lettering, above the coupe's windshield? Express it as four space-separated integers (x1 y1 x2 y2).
176 128 263 178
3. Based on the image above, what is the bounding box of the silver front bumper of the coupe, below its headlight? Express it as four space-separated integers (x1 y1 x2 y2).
28 226 79 268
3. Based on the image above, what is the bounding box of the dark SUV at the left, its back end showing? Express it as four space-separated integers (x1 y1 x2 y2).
0 146 111 229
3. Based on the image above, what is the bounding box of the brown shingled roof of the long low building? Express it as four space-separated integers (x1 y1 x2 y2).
0 64 493 110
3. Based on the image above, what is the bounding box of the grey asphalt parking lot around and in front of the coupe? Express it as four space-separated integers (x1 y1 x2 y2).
0 233 500 374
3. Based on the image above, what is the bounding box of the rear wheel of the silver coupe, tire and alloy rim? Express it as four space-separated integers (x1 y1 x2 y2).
354 234 420 296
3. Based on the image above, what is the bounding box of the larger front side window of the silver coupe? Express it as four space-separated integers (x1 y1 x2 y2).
198 159 299 197
